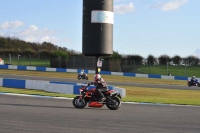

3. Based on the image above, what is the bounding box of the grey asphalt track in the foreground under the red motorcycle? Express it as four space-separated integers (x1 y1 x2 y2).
0 94 200 133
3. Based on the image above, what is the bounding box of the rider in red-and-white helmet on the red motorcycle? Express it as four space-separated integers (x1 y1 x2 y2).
88 74 108 102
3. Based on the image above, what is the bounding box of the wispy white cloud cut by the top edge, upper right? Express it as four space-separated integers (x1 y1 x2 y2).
151 0 188 11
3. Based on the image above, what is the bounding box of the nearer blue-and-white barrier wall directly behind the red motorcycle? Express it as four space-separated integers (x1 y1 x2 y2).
0 78 126 97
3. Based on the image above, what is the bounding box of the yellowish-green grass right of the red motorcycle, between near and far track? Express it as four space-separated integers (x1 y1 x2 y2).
122 86 200 106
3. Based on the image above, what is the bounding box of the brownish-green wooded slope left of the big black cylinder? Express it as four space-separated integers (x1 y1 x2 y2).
0 36 81 59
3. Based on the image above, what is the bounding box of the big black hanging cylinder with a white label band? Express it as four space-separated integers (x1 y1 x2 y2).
82 0 114 56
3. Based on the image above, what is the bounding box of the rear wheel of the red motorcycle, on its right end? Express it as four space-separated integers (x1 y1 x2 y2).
106 97 121 110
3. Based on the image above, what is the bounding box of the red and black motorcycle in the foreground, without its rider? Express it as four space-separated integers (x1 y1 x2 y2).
72 86 121 110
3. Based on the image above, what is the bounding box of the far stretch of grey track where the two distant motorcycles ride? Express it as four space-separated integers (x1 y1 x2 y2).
0 74 200 90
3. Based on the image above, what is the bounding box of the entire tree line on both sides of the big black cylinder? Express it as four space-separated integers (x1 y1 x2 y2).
0 36 200 65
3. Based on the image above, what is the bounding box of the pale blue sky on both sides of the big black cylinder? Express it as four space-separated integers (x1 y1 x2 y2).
0 0 200 58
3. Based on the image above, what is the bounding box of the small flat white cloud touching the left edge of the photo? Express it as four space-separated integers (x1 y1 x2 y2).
0 21 24 29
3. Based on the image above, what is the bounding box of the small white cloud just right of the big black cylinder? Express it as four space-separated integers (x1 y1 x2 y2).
114 2 135 14
